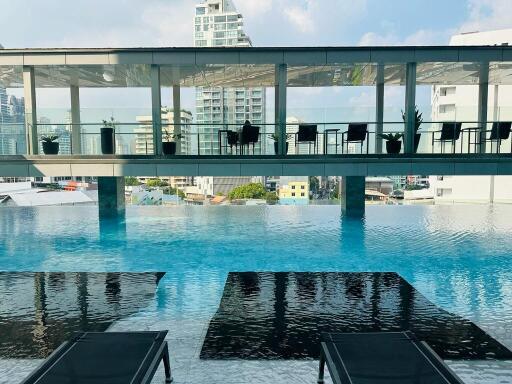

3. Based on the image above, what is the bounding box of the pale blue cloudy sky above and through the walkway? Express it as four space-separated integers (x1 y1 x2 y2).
0 0 512 120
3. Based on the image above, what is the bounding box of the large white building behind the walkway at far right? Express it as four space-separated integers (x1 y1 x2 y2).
429 29 512 203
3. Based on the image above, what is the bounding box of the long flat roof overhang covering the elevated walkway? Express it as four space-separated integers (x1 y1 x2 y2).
0 46 512 87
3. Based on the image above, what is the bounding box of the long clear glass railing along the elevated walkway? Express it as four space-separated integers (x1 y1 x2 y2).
5 121 512 156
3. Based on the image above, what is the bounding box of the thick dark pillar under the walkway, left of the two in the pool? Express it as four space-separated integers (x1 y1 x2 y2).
98 176 125 217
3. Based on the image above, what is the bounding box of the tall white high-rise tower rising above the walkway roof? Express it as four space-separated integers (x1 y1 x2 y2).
194 0 266 155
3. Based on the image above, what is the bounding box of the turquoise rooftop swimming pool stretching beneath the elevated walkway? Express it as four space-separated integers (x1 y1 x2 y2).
0 205 512 383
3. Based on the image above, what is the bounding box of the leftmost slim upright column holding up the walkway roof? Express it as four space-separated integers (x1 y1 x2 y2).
23 66 39 155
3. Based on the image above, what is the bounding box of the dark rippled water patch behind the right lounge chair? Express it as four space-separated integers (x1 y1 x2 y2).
201 272 512 360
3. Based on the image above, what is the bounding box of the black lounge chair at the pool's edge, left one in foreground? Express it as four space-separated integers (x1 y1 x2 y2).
21 331 172 384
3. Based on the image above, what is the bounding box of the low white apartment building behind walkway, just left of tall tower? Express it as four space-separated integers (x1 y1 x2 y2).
133 107 193 155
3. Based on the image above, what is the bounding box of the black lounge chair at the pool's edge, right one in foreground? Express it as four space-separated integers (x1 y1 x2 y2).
318 332 463 384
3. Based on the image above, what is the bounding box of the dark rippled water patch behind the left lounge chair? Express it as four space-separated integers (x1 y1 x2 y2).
0 272 163 358
